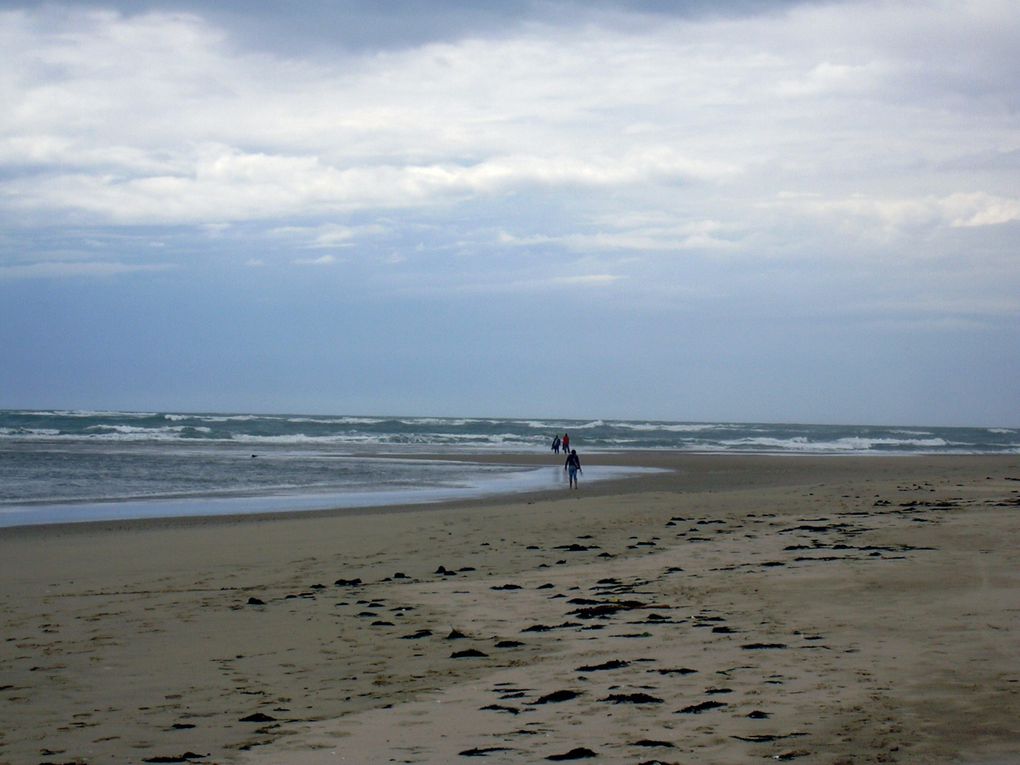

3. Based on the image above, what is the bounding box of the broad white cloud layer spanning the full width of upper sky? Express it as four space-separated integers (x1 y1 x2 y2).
0 0 1020 281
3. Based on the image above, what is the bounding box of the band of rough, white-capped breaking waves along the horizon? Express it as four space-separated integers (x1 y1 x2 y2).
0 410 1020 454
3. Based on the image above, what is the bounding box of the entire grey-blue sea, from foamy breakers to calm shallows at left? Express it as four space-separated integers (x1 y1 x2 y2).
0 410 1020 526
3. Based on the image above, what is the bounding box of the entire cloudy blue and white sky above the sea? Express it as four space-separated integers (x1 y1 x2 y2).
0 0 1020 426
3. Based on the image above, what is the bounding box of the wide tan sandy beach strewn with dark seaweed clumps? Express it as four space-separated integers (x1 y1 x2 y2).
0 453 1020 765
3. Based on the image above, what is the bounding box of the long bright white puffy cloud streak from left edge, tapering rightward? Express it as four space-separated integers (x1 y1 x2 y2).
4 147 735 224
